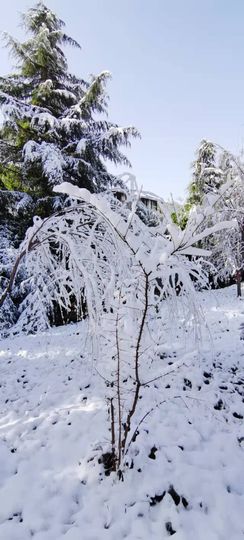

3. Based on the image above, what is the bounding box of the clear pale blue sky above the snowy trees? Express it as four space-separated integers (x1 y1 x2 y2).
0 0 244 199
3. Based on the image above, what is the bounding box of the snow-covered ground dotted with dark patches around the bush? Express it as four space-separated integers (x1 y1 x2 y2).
0 287 244 540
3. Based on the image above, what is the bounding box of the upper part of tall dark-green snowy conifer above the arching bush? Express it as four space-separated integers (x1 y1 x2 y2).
0 2 138 195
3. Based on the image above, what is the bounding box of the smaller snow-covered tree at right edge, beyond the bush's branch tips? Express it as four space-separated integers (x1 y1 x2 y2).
185 141 244 295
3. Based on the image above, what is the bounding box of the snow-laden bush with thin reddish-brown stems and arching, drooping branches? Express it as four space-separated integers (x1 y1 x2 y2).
0 183 233 474
